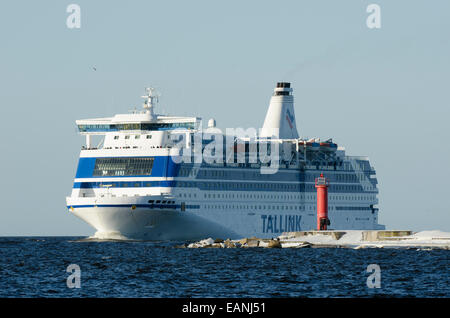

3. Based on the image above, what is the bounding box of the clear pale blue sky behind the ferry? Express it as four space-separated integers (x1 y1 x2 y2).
0 0 450 235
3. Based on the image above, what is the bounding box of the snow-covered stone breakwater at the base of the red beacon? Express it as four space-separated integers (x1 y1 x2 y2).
176 230 450 250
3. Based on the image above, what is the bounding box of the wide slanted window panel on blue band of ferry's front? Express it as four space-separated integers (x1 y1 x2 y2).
93 157 154 177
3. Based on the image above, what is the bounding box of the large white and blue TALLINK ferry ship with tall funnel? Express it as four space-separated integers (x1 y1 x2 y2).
66 82 384 240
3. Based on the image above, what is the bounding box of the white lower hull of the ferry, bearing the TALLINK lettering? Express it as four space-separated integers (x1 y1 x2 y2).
67 197 382 241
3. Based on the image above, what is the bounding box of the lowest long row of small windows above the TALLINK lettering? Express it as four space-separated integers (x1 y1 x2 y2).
179 193 375 201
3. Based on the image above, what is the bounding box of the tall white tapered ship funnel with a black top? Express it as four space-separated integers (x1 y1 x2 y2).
260 82 298 139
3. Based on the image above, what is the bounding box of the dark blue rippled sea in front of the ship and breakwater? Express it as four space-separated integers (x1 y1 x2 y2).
0 237 450 298
